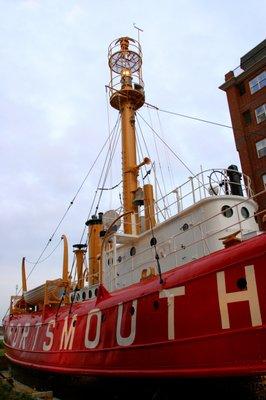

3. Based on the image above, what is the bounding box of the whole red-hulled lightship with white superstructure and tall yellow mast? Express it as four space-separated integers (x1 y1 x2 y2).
3 37 266 377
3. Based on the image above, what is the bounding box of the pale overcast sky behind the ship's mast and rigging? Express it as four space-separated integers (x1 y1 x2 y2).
0 0 266 317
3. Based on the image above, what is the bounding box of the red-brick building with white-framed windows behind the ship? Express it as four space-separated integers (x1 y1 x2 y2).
220 39 266 230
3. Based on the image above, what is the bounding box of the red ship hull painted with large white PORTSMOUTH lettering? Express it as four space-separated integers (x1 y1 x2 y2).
4 234 266 377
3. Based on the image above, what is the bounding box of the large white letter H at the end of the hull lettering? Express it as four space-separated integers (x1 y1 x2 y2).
216 265 262 329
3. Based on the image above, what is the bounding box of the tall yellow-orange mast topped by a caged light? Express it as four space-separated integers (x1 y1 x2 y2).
108 37 149 234
